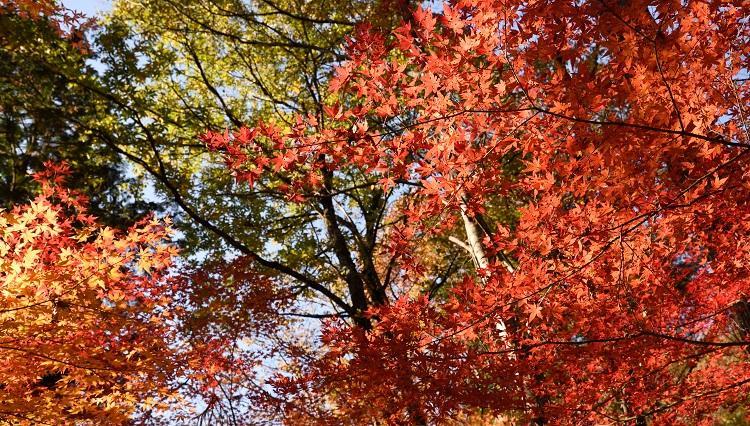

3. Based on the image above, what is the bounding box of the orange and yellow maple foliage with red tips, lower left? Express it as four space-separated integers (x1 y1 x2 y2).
0 163 223 424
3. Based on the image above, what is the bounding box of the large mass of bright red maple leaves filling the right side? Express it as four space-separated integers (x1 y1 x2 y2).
204 0 750 423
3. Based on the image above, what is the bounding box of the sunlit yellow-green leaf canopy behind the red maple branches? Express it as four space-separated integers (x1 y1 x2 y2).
84 0 408 266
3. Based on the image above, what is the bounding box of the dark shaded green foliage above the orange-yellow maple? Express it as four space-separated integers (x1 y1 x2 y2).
0 9 154 225
